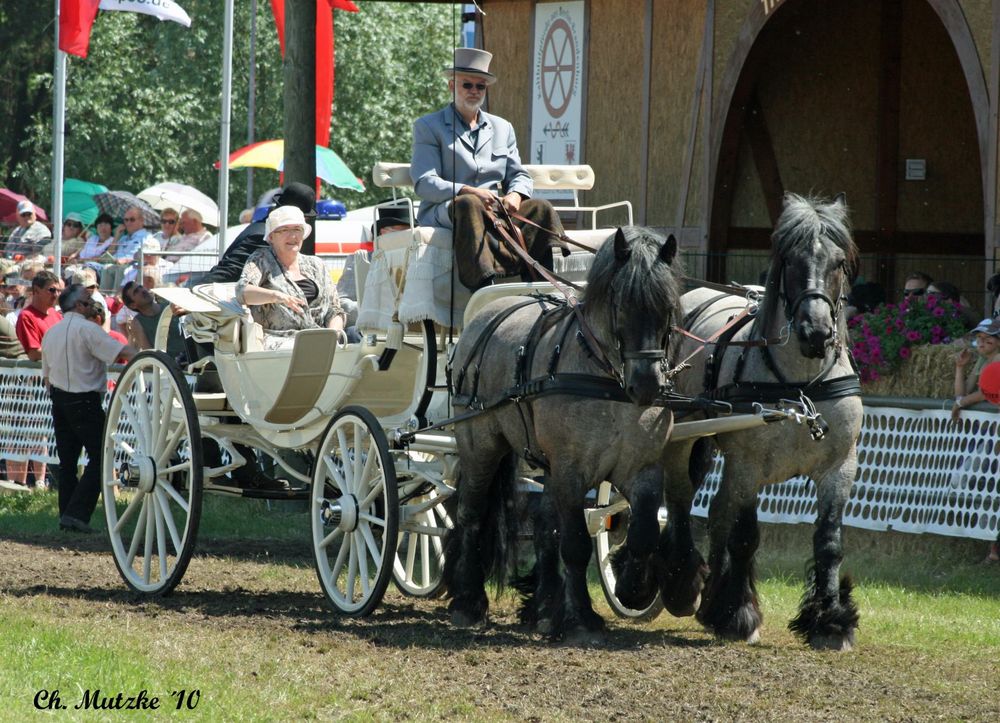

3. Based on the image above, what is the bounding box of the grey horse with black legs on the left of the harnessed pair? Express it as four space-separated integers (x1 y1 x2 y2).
444 227 680 637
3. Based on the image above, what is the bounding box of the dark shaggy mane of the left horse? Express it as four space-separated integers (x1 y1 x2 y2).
583 226 681 360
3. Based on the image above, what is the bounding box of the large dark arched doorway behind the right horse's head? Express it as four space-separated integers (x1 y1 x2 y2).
709 0 990 308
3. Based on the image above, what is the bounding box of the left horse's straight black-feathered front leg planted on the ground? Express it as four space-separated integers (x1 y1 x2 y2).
546 466 604 642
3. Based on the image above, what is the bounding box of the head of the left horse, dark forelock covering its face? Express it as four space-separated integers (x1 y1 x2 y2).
584 226 680 406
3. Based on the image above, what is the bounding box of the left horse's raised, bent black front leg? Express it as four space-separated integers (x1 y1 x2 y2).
611 465 663 610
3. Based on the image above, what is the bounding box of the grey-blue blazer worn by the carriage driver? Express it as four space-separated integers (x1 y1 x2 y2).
410 105 534 228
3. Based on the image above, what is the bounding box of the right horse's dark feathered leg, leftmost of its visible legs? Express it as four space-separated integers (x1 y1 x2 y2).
656 437 715 617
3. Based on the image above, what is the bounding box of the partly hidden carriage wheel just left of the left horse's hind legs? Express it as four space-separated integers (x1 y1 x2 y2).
392 452 456 598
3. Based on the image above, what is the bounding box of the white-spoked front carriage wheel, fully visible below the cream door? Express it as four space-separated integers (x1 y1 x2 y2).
310 407 399 617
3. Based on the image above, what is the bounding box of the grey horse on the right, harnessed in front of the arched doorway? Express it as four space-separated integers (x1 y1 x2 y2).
660 194 862 649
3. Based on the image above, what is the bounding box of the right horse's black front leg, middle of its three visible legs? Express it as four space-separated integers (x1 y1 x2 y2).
697 472 763 643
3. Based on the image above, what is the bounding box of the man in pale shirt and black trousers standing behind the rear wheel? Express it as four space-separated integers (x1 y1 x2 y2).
42 284 136 533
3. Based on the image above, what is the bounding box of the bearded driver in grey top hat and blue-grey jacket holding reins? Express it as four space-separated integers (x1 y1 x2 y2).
410 48 568 289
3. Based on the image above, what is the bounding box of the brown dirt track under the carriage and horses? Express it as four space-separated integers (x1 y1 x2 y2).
0 535 1000 720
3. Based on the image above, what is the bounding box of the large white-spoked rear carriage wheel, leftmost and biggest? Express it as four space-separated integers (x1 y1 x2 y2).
101 351 203 595
